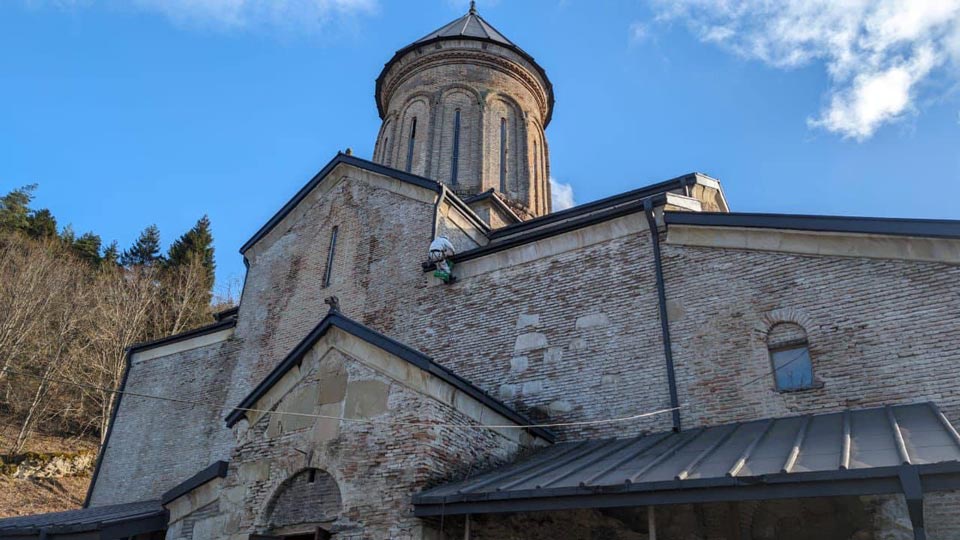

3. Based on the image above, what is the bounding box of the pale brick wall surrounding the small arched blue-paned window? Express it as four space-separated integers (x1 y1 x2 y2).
663 245 960 426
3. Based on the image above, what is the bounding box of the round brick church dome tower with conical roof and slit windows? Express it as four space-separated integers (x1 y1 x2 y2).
374 3 554 217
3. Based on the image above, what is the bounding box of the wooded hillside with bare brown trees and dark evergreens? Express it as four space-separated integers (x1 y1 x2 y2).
0 186 231 455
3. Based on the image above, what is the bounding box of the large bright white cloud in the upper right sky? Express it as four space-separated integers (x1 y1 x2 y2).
653 0 960 140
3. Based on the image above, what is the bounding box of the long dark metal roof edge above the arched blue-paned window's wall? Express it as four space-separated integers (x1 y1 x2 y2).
665 212 960 238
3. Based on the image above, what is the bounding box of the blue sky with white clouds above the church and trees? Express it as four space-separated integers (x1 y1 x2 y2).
0 0 960 292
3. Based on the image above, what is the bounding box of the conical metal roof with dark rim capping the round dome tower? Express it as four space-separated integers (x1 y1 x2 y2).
374 6 554 128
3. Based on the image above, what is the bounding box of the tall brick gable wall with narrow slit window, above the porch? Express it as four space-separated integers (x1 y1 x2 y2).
230 167 436 426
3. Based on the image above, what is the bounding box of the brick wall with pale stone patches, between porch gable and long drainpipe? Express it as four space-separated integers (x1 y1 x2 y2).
387 216 670 438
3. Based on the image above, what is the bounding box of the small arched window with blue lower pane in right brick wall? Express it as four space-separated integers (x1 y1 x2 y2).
767 322 819 392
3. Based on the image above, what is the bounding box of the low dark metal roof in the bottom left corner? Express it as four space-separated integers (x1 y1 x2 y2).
0 501 167 537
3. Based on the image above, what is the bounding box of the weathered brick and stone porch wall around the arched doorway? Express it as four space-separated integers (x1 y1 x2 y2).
202 342 519 540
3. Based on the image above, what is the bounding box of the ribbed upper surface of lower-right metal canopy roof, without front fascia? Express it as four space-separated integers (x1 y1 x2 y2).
414 403 960 515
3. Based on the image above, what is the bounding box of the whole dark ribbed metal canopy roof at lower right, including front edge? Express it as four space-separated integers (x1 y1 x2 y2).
414 403 960 516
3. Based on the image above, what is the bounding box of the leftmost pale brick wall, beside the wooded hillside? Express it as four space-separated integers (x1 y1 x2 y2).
90 339 239 506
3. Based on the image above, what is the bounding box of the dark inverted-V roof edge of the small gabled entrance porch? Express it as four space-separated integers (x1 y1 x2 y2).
226 310 554 442
